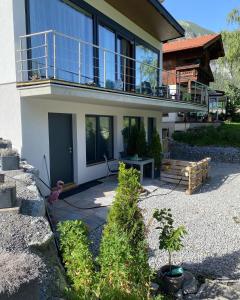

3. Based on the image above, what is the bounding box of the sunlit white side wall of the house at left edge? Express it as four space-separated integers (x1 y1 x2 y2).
0 0 25 152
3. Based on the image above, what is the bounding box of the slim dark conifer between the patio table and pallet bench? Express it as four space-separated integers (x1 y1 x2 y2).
148 129 162 178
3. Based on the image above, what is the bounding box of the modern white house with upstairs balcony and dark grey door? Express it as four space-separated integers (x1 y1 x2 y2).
0 0 207 190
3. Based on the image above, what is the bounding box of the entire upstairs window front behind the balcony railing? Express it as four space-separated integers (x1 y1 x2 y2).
26 0 159 95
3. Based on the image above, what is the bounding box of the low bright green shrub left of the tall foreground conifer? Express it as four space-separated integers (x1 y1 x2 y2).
58 220 95 300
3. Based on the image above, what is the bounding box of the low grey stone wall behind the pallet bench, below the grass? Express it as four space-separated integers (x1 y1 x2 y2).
169 142 240 163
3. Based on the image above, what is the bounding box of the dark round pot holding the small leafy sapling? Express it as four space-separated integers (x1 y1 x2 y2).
159 265 184 295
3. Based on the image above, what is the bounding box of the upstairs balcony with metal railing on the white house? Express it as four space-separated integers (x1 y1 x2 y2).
17 30 209 111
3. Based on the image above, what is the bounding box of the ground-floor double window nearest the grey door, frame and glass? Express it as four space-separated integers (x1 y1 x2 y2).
86 115 113 164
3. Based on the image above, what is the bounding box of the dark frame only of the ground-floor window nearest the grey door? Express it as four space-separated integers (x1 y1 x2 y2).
85 114 114 166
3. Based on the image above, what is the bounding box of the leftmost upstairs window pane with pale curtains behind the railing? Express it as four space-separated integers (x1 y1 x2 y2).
28 0 94 83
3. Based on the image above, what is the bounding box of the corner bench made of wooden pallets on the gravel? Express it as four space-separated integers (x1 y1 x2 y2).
161 157 211 195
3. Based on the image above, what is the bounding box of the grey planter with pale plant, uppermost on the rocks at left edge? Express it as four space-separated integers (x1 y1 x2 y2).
0 148 19 171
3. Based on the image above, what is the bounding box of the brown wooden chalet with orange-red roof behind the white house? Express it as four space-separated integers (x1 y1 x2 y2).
163 34 224 135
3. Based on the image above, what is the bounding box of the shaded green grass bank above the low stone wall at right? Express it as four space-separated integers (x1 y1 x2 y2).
173 123 240 148
